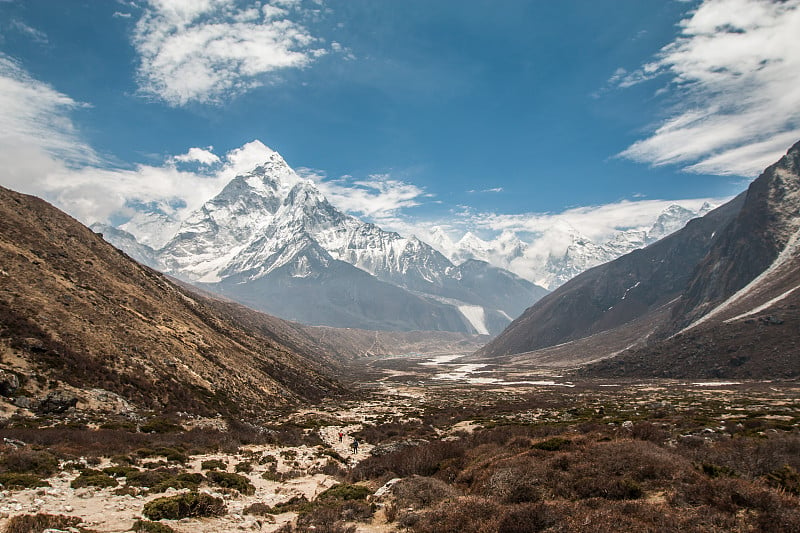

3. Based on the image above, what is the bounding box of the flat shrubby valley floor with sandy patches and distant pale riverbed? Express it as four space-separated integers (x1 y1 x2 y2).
0 356 800 533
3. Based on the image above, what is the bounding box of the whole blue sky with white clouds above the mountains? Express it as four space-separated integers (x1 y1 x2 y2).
0 0 800 248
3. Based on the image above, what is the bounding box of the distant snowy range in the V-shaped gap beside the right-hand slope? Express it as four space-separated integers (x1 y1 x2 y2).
430 203 712 290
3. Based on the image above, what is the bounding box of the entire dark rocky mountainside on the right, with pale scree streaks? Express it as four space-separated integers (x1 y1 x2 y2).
475 139 800 377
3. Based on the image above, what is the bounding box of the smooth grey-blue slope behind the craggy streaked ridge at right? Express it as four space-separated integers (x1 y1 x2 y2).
477 196 743 357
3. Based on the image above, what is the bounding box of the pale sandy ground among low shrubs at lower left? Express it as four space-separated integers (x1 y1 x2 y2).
0 403 394 533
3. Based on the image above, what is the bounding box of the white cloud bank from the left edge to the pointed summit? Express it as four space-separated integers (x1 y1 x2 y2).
0 51 282 224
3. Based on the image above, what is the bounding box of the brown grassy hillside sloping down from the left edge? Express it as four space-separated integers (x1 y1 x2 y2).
0 188 342 415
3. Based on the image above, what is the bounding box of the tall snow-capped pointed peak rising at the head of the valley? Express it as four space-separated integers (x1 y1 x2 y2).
115 152 546 334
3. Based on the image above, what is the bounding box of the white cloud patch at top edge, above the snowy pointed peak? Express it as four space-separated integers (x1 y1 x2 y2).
133 0 324 106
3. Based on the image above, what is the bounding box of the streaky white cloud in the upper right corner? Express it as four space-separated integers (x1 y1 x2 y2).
620 0 800 176
